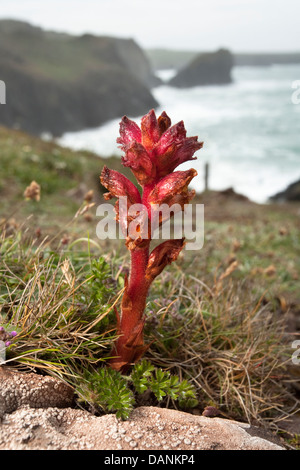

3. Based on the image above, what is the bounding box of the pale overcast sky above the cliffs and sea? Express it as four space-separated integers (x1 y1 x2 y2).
0 0 300 52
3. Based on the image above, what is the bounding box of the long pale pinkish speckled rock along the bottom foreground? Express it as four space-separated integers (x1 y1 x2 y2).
0 407 284 451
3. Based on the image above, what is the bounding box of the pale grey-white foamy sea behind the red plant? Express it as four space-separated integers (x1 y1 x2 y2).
58 65 300 203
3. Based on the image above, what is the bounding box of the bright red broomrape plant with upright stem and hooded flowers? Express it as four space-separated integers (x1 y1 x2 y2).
100 110 203 373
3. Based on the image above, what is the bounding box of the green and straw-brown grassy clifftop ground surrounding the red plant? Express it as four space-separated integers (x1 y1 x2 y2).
0 127 300 444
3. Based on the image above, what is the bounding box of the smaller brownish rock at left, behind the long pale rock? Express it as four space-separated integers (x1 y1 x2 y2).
0 367 74 419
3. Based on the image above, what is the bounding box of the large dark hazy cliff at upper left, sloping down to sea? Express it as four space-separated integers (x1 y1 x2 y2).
0 21 157 136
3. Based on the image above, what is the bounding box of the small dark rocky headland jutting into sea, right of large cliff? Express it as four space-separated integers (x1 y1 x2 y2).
169 49 233 88
